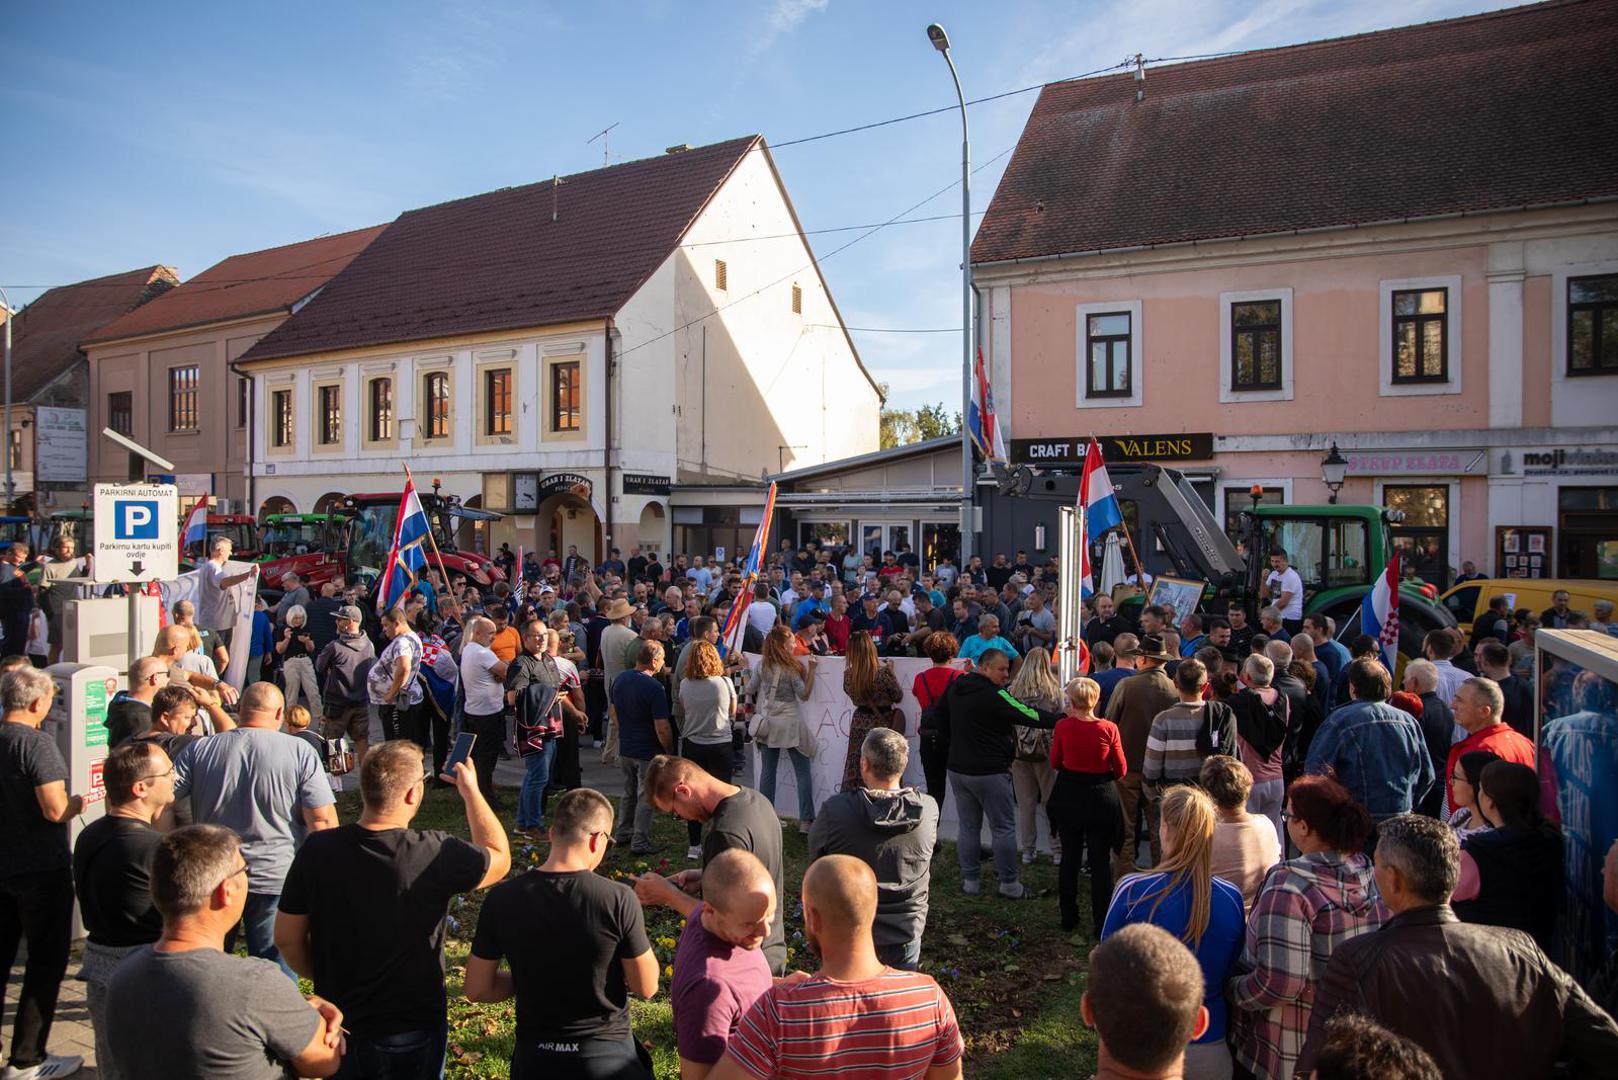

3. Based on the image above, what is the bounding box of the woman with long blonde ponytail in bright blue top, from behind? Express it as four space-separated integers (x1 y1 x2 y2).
1102 785 1246 1080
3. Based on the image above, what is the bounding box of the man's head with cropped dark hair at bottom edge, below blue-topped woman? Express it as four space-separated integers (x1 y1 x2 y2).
1079 923 1209 1080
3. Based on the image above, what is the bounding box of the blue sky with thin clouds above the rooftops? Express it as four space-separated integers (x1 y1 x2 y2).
0 0 1506 406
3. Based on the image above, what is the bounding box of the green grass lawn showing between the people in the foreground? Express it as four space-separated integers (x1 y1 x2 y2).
351 777 1095 1080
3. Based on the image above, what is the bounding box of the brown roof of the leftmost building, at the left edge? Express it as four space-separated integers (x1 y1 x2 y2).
11 266 180 402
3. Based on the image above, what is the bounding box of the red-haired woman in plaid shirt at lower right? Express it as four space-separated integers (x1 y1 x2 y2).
1228 776 1388 1080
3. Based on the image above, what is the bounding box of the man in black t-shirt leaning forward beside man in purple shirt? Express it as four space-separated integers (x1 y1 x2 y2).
634 755 786 975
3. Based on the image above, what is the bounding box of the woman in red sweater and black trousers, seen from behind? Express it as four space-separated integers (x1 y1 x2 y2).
1045 678 1129 934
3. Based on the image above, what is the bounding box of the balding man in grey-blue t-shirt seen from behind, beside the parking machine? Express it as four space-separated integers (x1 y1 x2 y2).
175 682 337 978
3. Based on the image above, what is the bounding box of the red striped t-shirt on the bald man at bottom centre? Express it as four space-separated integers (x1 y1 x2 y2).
726 968 966 1080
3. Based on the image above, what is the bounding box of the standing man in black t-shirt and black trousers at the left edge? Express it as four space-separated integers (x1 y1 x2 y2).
0 667 95 1080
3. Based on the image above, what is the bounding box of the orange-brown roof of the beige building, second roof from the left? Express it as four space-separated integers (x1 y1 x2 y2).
86 225 387 345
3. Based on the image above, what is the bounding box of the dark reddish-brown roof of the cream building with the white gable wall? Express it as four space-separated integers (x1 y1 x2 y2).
243 136 759 361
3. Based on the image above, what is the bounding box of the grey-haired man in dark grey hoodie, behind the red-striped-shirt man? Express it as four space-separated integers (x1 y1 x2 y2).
809 727 938 972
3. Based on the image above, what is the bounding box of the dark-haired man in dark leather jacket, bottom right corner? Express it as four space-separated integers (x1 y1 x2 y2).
1298 814 1618 1077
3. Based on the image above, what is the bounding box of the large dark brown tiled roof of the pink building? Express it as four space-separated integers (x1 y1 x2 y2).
972 0 1618 264
